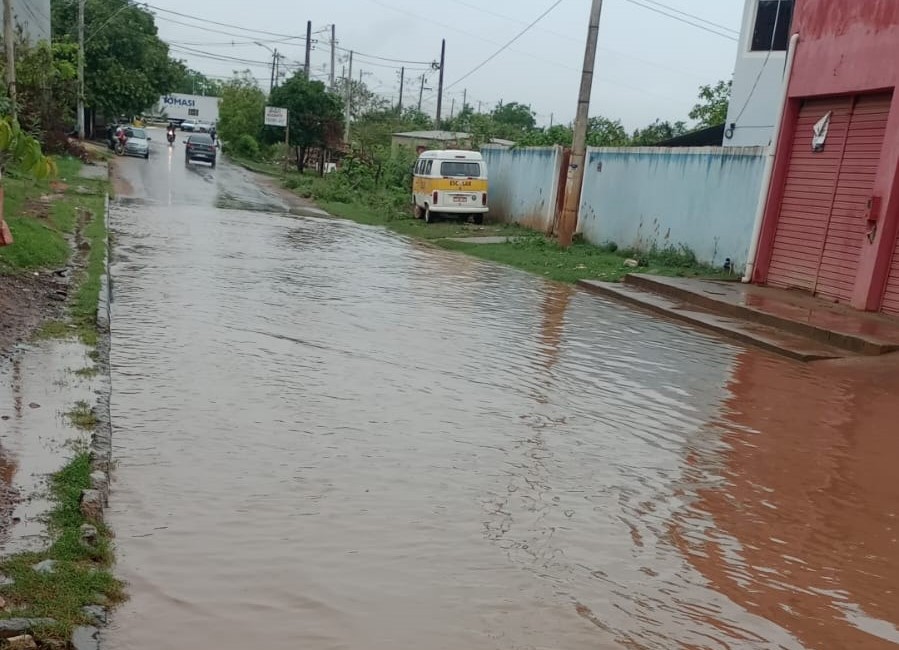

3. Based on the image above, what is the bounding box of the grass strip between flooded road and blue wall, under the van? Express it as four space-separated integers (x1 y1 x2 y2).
238 154 727 282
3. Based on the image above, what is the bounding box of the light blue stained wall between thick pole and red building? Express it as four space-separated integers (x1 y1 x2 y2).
579 147 765 269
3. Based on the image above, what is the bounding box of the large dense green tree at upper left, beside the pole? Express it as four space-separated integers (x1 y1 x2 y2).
51 0 182 116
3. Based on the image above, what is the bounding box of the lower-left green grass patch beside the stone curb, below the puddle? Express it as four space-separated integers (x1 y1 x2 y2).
0 450 124 640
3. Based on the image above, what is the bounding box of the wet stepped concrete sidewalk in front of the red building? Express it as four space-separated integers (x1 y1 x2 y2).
579 274 899 361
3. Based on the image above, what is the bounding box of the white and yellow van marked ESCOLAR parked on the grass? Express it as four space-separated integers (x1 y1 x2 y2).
412 150 489 223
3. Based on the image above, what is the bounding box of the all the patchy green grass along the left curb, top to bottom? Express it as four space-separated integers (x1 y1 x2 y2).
0 158 124 640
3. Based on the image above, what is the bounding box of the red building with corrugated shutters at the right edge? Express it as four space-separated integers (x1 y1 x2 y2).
748 0 899 315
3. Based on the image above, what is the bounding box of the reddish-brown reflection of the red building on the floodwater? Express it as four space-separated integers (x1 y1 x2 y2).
671 352 899 650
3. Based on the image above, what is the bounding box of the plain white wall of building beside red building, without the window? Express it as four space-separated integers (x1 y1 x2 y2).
723 0 787 147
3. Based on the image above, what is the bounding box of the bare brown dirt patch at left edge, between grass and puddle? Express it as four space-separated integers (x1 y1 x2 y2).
0 272 67 360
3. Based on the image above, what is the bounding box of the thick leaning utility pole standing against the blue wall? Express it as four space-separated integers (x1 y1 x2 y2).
558 0 602 248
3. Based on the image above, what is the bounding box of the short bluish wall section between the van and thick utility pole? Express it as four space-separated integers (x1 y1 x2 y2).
481 145 562 232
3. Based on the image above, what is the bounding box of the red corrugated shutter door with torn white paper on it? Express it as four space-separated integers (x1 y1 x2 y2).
768 94 892 302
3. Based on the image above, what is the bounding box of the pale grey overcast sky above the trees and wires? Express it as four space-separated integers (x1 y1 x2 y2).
149 0 744 129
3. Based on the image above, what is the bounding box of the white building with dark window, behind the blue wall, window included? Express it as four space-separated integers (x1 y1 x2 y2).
723 0 803 147
